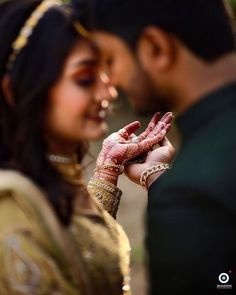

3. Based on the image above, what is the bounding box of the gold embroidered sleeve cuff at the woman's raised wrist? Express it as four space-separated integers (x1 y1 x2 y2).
88 178 122 218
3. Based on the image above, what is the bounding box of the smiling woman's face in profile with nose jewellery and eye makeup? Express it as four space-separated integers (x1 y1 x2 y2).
45 41 112 150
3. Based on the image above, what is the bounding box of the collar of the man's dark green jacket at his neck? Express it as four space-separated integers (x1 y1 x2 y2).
176 82 236 140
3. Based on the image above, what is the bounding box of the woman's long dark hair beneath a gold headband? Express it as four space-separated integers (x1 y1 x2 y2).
0 0 91 224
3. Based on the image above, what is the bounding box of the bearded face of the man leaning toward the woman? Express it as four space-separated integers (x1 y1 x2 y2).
95 32 159 114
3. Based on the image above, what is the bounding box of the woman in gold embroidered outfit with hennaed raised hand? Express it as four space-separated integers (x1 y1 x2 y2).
0 0 172 295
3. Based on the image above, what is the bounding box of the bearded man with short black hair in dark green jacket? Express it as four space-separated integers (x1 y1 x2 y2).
92 0 236 295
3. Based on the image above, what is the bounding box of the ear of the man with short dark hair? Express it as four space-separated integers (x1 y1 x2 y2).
137 26 176 73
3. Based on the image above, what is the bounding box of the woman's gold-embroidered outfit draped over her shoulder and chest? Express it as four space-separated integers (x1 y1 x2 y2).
0 170 130 295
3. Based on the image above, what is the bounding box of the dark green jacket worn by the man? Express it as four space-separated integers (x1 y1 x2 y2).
147 83 236 295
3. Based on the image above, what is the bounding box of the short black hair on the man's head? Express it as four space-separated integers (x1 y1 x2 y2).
91 0 235 60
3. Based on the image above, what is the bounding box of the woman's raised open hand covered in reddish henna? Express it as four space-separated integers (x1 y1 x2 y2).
96 112 173 174
